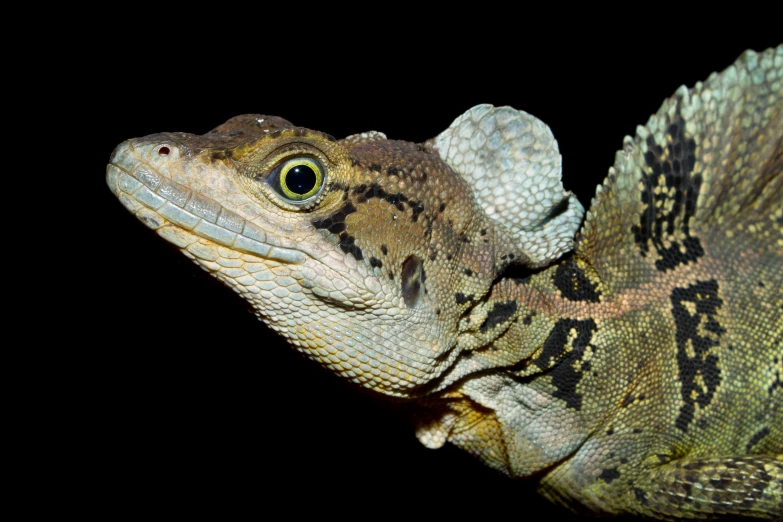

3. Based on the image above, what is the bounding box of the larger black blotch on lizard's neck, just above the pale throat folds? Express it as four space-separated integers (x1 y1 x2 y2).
533 319 598 410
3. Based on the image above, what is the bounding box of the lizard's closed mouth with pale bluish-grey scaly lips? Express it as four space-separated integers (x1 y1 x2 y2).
106 157 307 265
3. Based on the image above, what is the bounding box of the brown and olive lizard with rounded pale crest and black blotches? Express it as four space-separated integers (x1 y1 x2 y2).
107 46 783 519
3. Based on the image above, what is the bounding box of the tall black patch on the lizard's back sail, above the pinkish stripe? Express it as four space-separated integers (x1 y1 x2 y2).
631 114 704 271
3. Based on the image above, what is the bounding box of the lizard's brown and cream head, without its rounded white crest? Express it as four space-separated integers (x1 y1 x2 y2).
107 106 581 397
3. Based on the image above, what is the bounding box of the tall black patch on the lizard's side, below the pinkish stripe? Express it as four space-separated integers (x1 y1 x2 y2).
671 279 726 432
